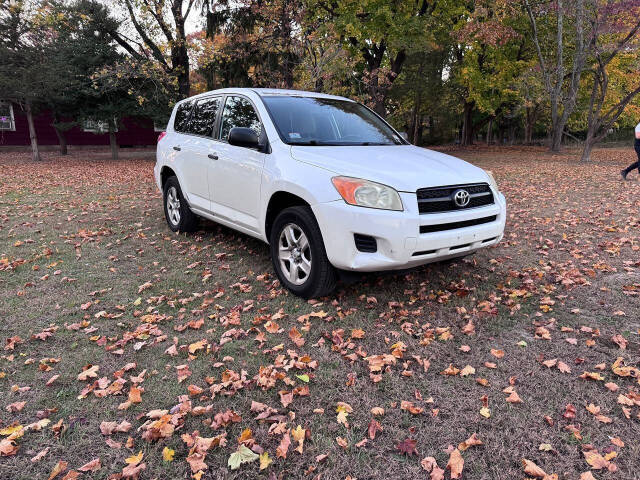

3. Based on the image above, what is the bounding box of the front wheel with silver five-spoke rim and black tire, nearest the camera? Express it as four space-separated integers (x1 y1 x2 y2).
269 206 337 299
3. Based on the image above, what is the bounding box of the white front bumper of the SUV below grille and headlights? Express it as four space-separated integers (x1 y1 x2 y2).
311 192 507 272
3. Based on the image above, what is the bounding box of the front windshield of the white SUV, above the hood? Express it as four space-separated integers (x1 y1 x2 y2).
262 96 404 145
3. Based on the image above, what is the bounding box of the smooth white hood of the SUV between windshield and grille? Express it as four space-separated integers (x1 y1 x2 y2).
291 145 488 192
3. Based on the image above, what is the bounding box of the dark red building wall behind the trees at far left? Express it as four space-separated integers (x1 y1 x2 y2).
0 104 158 147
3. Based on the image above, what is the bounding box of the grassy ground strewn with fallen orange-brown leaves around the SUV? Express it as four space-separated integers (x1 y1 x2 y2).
0 147 640 480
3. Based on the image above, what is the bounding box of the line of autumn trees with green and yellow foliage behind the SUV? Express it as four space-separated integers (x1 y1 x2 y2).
5 0 640 158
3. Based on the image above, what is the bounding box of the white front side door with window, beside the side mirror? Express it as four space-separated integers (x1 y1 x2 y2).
209 95 265 231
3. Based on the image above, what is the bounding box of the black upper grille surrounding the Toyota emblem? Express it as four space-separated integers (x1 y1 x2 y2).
416 183 493 213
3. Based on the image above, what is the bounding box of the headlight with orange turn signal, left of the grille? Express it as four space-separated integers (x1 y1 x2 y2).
331 177 403 211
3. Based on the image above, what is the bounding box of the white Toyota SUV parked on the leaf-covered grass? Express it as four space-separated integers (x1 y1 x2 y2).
154 88 506 298
